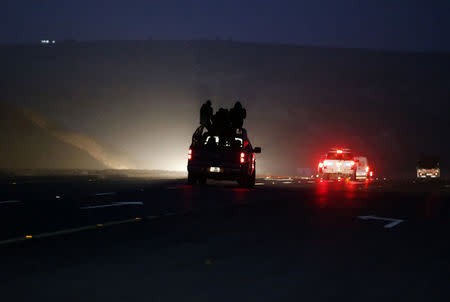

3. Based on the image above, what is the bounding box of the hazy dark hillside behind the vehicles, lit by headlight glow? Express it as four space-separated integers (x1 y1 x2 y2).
0 40 450 175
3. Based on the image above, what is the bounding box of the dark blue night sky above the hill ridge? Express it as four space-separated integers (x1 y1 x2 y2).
0 0 450 52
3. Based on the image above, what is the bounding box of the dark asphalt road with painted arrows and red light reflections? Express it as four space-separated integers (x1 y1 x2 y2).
0 177 450 301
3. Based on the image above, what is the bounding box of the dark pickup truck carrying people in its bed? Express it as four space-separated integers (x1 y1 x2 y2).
187 129 261 187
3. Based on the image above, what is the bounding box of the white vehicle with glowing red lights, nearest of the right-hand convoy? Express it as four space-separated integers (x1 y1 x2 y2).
319 148 356 180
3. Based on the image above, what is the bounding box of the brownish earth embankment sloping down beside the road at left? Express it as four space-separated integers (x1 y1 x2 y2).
0 102 135 170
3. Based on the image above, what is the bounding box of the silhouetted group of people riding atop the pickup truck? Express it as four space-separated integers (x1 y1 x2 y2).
200 100 247 135
